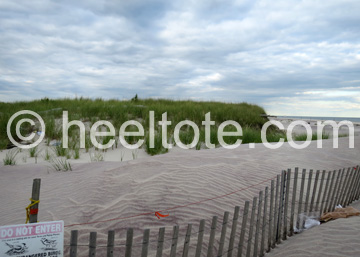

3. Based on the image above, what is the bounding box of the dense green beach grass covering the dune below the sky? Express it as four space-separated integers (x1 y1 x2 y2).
0 98 285 156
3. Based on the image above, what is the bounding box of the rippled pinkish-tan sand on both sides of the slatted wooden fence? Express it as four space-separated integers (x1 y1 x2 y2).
0 119 360 256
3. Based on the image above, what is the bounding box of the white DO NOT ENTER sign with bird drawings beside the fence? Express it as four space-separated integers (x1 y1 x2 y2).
0 220 64 257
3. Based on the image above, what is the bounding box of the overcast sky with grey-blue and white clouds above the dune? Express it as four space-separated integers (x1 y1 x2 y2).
0 0 360 117
